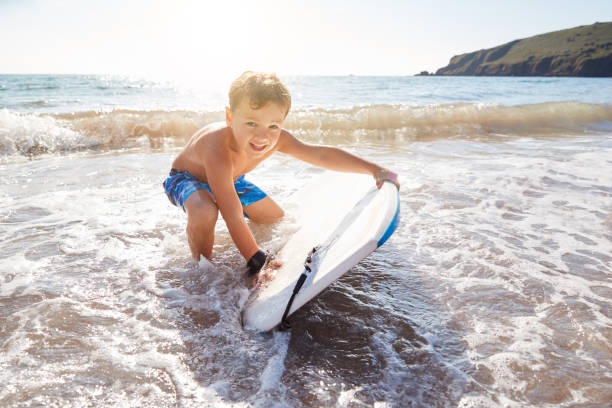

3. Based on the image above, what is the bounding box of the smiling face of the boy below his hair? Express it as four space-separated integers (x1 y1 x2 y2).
225 99 285 158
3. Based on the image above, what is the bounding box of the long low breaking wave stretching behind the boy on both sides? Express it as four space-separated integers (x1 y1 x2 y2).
0 102 612 156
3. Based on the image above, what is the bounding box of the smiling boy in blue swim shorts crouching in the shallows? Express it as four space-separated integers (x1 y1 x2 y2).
164 71 399 279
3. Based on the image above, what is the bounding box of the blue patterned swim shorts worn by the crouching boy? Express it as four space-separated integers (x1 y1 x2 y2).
163 169 266 210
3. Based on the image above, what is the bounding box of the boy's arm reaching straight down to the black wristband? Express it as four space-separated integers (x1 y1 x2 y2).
203 143 259 260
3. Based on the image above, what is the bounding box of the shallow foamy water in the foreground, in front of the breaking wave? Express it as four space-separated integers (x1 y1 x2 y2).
0 134 612 407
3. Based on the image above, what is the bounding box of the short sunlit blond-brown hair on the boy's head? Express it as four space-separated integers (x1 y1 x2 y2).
229 71 291 116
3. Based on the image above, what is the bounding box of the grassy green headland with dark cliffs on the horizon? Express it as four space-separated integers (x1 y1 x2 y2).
436 22 612 77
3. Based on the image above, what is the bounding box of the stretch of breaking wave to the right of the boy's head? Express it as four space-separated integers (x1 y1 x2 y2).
286 102 612 141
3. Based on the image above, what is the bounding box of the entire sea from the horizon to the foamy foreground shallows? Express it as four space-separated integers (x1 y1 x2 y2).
0 75 612 408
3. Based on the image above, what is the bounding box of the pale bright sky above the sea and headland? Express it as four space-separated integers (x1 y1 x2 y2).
0 0 612 81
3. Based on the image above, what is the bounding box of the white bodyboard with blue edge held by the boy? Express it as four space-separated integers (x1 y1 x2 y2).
242 172 399 331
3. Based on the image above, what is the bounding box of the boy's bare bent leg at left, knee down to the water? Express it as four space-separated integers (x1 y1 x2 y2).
185 190 219 260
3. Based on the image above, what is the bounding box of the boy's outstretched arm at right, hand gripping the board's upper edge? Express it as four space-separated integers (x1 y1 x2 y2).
278 130 399 188
